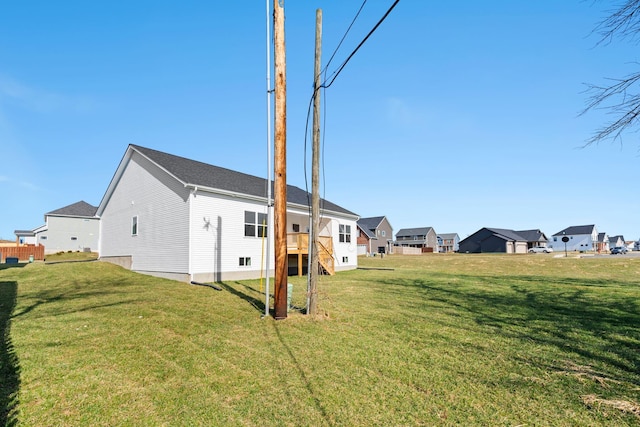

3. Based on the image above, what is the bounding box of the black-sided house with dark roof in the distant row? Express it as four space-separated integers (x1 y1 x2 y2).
458 227 528 254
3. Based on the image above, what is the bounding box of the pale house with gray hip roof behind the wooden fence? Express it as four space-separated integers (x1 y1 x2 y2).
32 201 100 254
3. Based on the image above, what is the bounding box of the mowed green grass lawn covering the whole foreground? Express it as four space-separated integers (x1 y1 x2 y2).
0 254 640 426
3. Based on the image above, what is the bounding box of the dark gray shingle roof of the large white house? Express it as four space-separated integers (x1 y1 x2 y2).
130 144 357 216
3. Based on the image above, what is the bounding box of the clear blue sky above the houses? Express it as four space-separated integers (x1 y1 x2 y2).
0 0 640 244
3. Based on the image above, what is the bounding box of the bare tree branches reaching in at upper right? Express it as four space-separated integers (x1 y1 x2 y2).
581 0 640 145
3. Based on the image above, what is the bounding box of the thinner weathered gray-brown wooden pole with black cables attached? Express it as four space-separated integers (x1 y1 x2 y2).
307 9 322 317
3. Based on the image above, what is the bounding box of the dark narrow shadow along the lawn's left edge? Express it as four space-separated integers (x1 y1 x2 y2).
0 282 20 426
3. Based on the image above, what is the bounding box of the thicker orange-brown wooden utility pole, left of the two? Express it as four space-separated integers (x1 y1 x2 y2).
273 0 288 320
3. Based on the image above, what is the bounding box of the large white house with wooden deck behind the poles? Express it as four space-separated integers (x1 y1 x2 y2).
98 145 358 282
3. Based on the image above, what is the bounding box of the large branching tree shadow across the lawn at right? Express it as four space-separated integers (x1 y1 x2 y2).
383 274 640 386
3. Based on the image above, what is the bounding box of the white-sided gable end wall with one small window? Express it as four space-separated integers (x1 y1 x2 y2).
100 152 189 274
